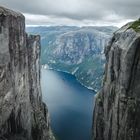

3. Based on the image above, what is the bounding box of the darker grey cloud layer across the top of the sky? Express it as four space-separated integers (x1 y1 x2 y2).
0 0 140 22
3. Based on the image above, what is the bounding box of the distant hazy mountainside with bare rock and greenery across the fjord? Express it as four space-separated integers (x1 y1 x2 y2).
27 26 117 90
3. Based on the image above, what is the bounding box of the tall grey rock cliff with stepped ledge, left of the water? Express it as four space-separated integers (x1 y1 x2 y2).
0 7 52 140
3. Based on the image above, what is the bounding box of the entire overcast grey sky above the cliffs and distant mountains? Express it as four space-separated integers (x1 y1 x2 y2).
0 0 140 27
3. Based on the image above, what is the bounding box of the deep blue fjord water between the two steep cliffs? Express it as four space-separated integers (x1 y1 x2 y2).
41 69 95 140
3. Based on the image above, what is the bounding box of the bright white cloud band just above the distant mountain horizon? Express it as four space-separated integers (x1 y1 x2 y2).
24 13 131 27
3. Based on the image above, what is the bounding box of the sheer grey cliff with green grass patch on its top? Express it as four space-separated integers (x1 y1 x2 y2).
93 21 140 140
